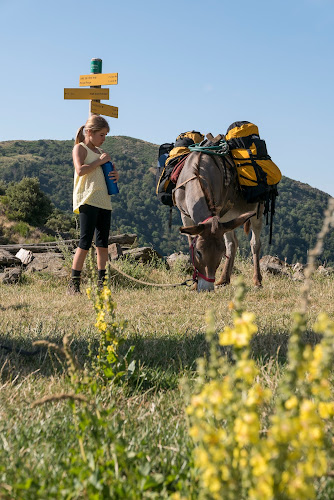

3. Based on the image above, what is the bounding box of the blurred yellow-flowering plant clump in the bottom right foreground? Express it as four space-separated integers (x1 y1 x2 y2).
187 283 334 500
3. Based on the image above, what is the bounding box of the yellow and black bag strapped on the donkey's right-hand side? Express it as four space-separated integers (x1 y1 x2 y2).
225 121 282 202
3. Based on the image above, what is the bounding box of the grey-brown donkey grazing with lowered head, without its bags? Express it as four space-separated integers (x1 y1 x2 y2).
174 148 263 291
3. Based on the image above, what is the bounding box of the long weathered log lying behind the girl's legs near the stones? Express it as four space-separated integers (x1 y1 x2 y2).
0 234 137 255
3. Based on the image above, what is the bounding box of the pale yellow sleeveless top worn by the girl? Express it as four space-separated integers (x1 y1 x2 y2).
73 142 112 214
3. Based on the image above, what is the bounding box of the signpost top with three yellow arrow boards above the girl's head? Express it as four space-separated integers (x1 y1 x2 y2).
64 59 118 118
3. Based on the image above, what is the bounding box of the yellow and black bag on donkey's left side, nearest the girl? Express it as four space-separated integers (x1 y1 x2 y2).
156 130 204 207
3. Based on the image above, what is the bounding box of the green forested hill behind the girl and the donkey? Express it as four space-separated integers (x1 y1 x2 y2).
0 136 334 263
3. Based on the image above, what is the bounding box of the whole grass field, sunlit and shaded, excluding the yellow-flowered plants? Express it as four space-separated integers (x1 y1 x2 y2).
0 258 334 500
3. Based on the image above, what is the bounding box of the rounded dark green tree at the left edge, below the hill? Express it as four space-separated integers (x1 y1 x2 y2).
3 177 53 226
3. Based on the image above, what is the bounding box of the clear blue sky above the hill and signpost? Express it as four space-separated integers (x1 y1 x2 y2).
0 0 334 196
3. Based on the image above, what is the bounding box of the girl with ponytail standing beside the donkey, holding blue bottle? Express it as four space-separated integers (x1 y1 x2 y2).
69 115 119 293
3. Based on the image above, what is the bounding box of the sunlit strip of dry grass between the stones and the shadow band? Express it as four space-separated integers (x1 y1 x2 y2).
0 259 334 362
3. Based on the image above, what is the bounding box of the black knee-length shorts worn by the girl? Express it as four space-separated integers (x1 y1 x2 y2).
78 205 111 250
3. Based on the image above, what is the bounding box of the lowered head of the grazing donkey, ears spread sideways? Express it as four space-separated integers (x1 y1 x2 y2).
180 212 255 292
